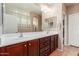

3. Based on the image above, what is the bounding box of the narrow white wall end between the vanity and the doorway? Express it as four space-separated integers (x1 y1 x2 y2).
57 3 63 51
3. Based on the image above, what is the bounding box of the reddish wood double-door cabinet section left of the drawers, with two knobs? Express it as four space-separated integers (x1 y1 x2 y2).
0 39 39 56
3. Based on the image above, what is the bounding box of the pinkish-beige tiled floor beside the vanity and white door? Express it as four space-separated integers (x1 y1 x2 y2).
50 46 79 56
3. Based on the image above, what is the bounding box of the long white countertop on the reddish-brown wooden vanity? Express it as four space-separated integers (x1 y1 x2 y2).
0 31 58 47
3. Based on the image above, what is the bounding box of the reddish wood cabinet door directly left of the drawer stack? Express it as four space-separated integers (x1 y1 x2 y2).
28 39 39 56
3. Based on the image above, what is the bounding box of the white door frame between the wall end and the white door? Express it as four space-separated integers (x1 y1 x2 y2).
62 14 68 46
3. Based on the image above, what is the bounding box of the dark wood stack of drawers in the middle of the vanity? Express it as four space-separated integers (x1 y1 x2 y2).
40 36 50 56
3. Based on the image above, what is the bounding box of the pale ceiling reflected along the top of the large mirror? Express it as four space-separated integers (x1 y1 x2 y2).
5 3 41 14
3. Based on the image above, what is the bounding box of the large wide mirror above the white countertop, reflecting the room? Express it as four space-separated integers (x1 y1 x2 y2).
3 3 42 33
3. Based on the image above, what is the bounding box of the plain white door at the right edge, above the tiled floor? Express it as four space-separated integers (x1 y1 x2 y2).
69 13 79 47
